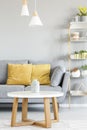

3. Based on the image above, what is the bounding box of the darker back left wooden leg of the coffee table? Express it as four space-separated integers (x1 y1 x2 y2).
22 98 28 121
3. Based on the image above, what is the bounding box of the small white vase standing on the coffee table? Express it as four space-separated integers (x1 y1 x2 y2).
31 79 40 93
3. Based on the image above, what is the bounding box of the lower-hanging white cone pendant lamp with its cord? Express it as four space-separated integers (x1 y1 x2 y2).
29 0 43 26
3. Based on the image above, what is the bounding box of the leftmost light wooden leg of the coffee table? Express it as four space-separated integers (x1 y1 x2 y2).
11 98 18 126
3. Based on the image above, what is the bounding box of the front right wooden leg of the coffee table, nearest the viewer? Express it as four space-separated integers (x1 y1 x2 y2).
44 98 51 128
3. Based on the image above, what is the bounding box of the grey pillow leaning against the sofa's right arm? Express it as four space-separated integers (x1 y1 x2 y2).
51 66 65 87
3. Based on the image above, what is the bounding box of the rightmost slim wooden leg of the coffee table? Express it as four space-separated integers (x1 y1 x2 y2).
52 97 59 121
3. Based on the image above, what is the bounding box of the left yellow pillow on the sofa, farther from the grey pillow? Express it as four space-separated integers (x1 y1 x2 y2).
7 64 32 85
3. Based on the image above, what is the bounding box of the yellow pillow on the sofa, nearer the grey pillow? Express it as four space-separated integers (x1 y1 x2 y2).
31 64 50 84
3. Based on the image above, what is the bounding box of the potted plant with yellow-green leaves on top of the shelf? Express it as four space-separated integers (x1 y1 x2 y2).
77 7 87 22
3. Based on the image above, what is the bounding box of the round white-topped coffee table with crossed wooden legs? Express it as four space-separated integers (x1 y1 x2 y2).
8 91 63 128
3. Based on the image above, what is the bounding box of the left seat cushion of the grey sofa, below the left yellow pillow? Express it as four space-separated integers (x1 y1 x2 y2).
0 85 24 98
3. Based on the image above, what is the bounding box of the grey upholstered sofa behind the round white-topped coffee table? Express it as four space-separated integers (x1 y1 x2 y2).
0 60 69 103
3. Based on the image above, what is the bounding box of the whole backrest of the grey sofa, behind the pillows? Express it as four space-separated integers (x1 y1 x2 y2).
0 60 65 84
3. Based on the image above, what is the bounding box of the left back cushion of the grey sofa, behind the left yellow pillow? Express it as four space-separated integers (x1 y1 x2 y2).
0 60 28 84
